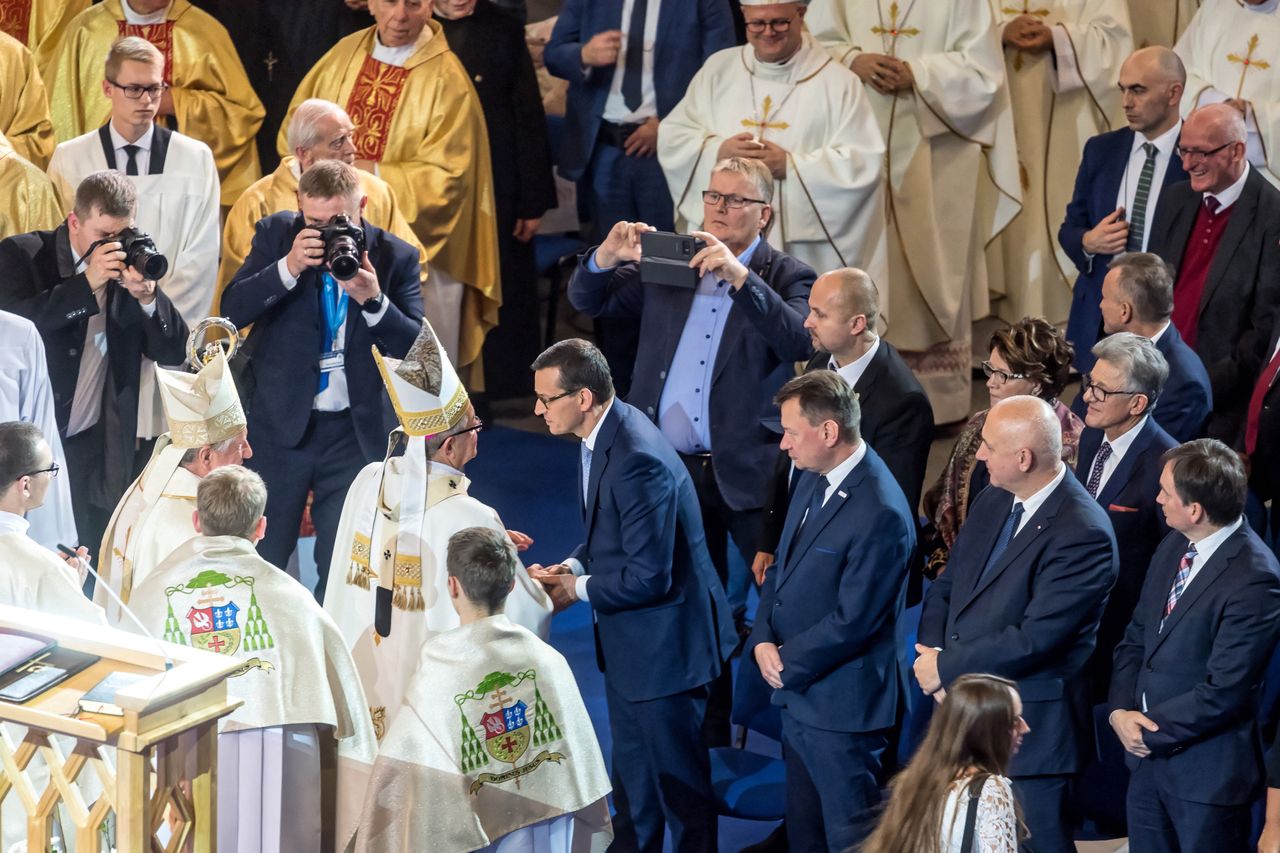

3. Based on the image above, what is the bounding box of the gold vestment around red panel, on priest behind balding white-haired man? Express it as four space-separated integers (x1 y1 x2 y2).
276 20 502 368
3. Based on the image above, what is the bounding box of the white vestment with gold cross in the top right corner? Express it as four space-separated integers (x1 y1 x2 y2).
1174 0 1280 186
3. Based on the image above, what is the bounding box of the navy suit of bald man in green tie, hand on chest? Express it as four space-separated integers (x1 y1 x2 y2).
1057 127 1187 373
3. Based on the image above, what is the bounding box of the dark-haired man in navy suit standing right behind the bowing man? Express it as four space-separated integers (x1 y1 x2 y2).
748 370 916 852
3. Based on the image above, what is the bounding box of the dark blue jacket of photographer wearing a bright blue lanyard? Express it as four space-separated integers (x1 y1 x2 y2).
221 210 422 461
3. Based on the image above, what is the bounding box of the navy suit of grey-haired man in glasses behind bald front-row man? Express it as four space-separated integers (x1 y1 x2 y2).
1075 418 1178 702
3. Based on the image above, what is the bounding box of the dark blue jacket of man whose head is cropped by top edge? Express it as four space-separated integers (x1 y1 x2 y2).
543 0 735 181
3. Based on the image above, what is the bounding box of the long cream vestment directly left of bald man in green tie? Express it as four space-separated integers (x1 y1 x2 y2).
987 0 1133 325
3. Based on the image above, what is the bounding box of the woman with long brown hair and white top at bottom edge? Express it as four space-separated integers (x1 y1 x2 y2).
860 675 1029 853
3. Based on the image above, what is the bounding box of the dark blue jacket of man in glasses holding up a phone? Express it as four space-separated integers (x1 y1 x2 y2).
568 240 817 510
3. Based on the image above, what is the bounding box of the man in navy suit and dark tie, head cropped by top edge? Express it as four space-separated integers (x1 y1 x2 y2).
543 0 735 397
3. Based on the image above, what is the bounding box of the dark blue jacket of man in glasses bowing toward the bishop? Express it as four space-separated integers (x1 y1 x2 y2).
572 400 737 702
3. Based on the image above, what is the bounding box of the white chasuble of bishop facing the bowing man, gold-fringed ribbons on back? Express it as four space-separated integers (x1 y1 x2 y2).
324 437 552 739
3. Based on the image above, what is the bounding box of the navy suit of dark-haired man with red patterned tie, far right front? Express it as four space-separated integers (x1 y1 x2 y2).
1110 524 1280 853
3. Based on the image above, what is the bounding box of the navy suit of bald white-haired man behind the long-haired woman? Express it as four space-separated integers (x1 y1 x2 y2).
919 471 1117 853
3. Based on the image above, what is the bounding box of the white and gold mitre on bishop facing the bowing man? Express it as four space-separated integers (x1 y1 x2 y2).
374 320 470 435
